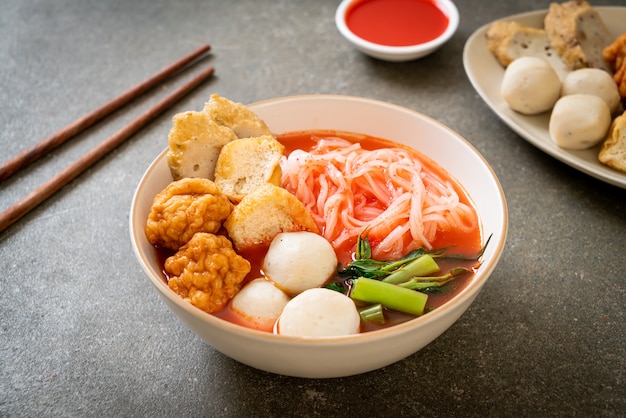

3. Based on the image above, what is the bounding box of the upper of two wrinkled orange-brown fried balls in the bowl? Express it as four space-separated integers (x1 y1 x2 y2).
146 178 232 250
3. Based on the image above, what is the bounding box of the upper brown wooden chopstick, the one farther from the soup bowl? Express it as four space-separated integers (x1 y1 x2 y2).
0 45 211 181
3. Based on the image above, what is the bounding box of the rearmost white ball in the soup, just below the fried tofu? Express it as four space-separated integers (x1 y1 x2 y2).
263 231 337 295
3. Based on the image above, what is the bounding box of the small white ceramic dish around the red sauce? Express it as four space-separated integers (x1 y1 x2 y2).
335 0 459 61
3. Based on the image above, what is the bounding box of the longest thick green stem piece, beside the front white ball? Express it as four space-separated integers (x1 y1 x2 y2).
349 277 428 316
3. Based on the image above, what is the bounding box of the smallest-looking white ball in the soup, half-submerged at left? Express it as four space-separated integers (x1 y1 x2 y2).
230 279 289 331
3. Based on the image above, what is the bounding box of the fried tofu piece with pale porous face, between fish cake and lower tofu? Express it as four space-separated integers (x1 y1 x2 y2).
215 135 285 201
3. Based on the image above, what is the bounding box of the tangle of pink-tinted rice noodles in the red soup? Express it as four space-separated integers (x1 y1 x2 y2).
281 137 478 260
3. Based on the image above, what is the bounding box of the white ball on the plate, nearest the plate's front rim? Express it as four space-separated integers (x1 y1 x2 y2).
548 94 611 150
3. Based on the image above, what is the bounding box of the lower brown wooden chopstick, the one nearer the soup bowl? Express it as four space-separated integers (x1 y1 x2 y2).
0 67 214 232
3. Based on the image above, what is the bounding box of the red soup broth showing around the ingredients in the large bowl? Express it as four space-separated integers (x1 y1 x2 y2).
157 130 482 332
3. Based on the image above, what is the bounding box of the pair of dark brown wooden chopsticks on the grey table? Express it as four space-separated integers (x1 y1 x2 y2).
0 45 214 232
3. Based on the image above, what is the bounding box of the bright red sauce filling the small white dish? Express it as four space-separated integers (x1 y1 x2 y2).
346 0 449 46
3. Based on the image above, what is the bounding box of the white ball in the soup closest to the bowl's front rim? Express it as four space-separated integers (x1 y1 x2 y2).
276 288 361 337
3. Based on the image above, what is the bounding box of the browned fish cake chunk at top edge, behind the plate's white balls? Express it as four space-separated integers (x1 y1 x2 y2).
544 0 613 71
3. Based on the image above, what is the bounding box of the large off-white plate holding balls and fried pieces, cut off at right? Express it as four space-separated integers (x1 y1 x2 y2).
463 7 626 188
